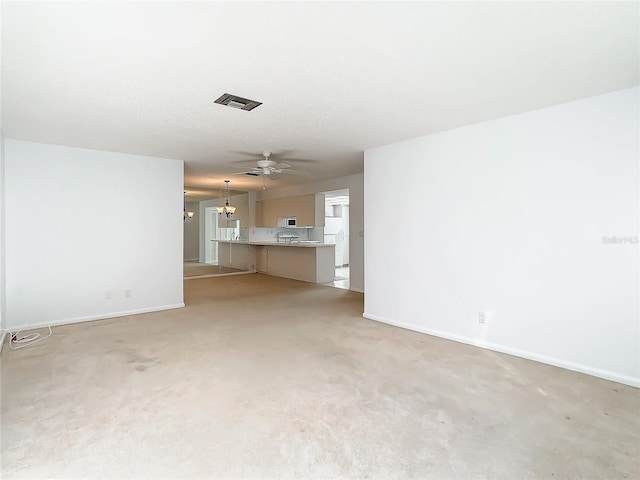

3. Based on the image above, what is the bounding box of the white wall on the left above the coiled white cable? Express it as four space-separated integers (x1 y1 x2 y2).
5 139 183 328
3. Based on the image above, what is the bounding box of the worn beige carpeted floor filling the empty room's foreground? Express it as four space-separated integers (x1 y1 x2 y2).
1 274 640 479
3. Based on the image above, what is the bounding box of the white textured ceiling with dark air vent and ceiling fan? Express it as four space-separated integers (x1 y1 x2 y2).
1 1 639 190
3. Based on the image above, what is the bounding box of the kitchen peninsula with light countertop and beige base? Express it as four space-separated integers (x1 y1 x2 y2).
216 240 335 283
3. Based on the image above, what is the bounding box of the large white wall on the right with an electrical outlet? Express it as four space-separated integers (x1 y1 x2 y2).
364 87 640 386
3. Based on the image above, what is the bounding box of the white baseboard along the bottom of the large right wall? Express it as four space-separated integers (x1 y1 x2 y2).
362 312 640 388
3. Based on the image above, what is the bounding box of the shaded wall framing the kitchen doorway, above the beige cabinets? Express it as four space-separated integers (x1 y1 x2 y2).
257 174 364 292
